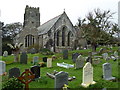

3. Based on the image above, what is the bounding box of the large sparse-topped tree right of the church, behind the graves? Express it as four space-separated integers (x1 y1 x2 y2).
77 9 114 51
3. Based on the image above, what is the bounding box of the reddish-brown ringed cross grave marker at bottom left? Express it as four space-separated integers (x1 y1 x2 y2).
18 69 35 90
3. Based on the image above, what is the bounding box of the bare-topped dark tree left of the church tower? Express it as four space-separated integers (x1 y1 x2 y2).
1 22 22 54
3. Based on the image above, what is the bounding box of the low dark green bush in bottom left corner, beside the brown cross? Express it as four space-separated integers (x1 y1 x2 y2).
2 77 23 90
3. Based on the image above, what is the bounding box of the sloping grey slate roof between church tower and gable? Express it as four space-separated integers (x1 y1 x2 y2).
37 14 62 35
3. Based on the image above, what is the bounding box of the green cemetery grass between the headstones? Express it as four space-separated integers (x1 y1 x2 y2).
2 47 120 88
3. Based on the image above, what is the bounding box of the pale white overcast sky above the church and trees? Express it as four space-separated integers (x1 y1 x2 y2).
0 0 120 25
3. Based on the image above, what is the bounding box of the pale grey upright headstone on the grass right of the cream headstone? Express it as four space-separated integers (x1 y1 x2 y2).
103 63 115 80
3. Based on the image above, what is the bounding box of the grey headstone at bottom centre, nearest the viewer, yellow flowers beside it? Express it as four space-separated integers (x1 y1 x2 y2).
55 71 68 90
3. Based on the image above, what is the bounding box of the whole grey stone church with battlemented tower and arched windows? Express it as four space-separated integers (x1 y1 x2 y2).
14 6 86 52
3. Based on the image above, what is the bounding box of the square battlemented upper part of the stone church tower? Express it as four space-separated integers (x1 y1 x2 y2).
23 5 40 28
